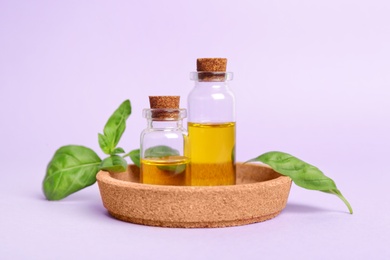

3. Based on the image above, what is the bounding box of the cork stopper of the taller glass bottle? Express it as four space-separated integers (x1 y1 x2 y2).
196 58 227 81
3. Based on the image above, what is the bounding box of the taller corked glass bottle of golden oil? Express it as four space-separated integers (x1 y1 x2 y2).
187 58 236 186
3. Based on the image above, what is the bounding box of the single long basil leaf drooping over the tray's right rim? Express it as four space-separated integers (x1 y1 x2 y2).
247 152 353 214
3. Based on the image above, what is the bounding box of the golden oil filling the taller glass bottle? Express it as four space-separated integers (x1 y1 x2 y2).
188 122 236 186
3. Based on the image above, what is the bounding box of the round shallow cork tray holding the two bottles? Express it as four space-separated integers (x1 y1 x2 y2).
97 163 291 228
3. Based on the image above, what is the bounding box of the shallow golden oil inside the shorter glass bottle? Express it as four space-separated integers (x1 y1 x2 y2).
140 156 190 186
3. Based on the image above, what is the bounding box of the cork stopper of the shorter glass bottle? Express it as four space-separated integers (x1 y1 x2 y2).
149 96 180 121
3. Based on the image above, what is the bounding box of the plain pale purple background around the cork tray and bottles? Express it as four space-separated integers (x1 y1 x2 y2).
0 0 390 259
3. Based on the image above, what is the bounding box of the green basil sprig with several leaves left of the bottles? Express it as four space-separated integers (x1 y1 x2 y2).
42 100 131 200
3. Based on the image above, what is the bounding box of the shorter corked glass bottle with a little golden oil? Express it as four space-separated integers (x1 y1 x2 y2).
140 96 190 185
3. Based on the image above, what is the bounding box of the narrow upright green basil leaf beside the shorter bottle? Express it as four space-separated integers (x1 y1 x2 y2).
99 100 131 154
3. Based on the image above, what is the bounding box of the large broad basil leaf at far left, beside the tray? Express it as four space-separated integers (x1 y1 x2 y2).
43 145 101 200
